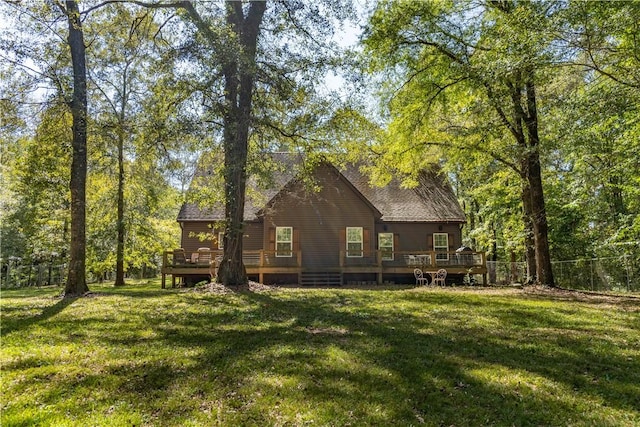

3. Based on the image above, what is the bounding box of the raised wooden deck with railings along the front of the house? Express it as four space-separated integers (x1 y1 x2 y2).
162 250 487 289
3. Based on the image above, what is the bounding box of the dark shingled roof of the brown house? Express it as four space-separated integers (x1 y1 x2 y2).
178 153 465 226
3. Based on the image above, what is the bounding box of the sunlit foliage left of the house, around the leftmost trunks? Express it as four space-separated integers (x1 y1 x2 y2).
2 4 184 278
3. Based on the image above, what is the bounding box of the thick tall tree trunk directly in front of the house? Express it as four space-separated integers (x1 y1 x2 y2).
218 1 266 286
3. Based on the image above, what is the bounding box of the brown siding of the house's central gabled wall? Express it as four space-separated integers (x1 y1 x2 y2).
264 166 376 270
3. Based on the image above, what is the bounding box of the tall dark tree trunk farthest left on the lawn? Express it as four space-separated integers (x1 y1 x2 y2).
64 0 89 296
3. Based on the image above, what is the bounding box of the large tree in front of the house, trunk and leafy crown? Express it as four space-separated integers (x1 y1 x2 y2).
135 1 356 286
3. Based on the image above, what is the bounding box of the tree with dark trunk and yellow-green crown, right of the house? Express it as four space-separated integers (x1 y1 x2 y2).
365 1 554 285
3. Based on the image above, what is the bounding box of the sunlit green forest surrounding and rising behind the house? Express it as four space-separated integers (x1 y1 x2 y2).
0 0 640 290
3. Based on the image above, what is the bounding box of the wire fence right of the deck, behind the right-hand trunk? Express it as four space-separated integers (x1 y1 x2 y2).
487 255 640 292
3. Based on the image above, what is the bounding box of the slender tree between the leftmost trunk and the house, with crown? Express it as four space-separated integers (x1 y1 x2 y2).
90 4 164 286
